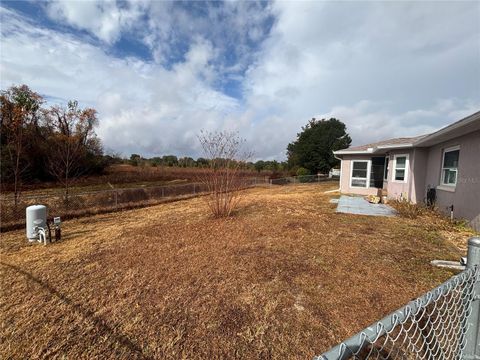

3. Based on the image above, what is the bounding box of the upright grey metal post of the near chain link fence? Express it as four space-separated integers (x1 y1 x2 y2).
463 237 480 360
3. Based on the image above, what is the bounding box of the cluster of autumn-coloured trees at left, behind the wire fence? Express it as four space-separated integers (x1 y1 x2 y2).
0 85 106 203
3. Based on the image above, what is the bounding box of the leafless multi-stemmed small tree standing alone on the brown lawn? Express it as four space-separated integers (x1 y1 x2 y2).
198 131 252 217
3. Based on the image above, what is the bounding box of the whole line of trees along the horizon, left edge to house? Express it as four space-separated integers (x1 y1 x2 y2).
0 85 351 203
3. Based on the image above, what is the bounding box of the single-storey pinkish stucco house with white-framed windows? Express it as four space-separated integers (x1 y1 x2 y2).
334 111 480 231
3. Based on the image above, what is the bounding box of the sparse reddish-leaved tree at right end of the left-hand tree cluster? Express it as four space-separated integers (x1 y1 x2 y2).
45 101 100 205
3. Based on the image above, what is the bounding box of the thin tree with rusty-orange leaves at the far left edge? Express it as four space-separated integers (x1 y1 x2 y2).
0 85 43 206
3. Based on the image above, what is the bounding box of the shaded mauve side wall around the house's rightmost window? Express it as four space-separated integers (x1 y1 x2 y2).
425 131 480 230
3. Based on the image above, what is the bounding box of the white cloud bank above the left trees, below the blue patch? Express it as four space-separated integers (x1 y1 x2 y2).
1 6 238 155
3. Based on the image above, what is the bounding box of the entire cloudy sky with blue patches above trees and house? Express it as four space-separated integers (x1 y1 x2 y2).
0 1 480 160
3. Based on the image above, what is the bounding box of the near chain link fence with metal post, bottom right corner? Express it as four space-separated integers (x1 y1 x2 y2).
315 238 480 360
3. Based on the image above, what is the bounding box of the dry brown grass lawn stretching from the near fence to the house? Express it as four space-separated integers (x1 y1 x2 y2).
0 183 471 359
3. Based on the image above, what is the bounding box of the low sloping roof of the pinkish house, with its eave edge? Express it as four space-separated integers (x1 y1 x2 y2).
333 111 480 155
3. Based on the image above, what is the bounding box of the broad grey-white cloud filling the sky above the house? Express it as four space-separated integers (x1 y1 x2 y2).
240 1 480 156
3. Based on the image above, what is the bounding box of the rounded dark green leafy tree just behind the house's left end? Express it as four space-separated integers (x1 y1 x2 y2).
287 118 352 174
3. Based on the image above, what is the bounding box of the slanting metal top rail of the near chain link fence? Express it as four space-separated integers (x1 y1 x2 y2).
314 266 480 360
